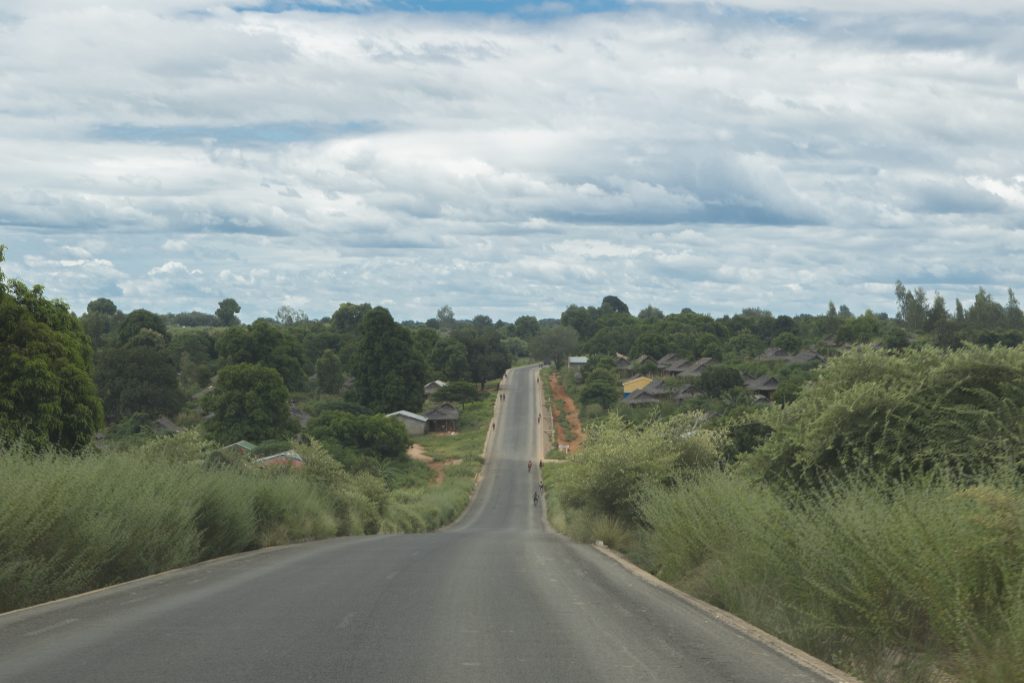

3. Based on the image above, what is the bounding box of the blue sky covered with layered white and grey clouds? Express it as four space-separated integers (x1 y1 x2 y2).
0 0 1024 322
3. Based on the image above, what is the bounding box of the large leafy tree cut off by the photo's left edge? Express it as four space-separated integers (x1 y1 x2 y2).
0 245 103 451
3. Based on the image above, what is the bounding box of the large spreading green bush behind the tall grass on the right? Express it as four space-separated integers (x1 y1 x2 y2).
745 346 1024 484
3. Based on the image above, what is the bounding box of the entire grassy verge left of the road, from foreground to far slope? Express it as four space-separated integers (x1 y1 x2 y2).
0 397 494 611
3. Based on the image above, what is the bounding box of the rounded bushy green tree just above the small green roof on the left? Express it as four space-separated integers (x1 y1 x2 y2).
203 362 297 443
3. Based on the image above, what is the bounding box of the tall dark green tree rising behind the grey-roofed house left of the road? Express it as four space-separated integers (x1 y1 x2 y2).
353 306 426 413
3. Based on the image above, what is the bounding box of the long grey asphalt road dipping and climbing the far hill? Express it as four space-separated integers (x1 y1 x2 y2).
0 370 843 683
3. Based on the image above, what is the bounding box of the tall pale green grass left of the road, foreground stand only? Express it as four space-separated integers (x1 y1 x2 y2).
0 436 338 611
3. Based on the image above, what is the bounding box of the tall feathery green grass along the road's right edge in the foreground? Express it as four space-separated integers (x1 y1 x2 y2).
642 471 1024 681
